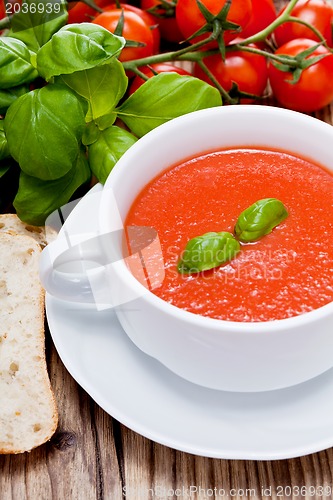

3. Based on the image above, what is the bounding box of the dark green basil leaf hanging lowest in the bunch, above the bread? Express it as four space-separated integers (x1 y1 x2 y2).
14 152 91 226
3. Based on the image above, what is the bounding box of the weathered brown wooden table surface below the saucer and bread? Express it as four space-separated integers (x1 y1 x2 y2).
0 2 333 500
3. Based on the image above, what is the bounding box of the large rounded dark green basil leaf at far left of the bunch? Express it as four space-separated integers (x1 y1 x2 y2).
5 85 87 180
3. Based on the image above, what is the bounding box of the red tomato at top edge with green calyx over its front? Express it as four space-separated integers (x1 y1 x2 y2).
176 0 252 43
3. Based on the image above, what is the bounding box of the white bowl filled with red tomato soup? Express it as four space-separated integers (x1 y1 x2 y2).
96 106 333 391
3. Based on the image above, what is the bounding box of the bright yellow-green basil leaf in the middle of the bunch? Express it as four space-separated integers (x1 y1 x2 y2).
59 59 128 122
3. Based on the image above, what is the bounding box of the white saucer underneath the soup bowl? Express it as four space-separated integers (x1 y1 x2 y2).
46 186 333 460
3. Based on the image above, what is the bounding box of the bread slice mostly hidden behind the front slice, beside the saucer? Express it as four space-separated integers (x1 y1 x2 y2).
0 214 57 248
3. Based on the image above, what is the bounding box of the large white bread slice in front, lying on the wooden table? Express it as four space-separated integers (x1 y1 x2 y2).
0 232 58 453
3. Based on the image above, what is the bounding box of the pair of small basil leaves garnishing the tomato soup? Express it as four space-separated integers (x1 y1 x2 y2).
177 198 288 274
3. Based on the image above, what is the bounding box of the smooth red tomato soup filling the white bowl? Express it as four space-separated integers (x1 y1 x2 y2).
125 148 333 322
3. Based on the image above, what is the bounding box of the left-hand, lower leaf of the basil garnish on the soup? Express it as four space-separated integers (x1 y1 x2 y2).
177 231 240 274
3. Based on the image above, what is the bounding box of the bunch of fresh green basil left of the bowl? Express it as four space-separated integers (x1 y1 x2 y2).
0 0 222 225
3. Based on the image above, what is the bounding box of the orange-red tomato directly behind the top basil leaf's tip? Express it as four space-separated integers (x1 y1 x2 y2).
92 9 154 61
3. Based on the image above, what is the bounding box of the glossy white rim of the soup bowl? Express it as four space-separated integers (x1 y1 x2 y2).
99 105 333 335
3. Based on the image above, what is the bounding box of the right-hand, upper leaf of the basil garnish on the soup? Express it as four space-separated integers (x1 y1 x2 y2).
235 198 288 243
